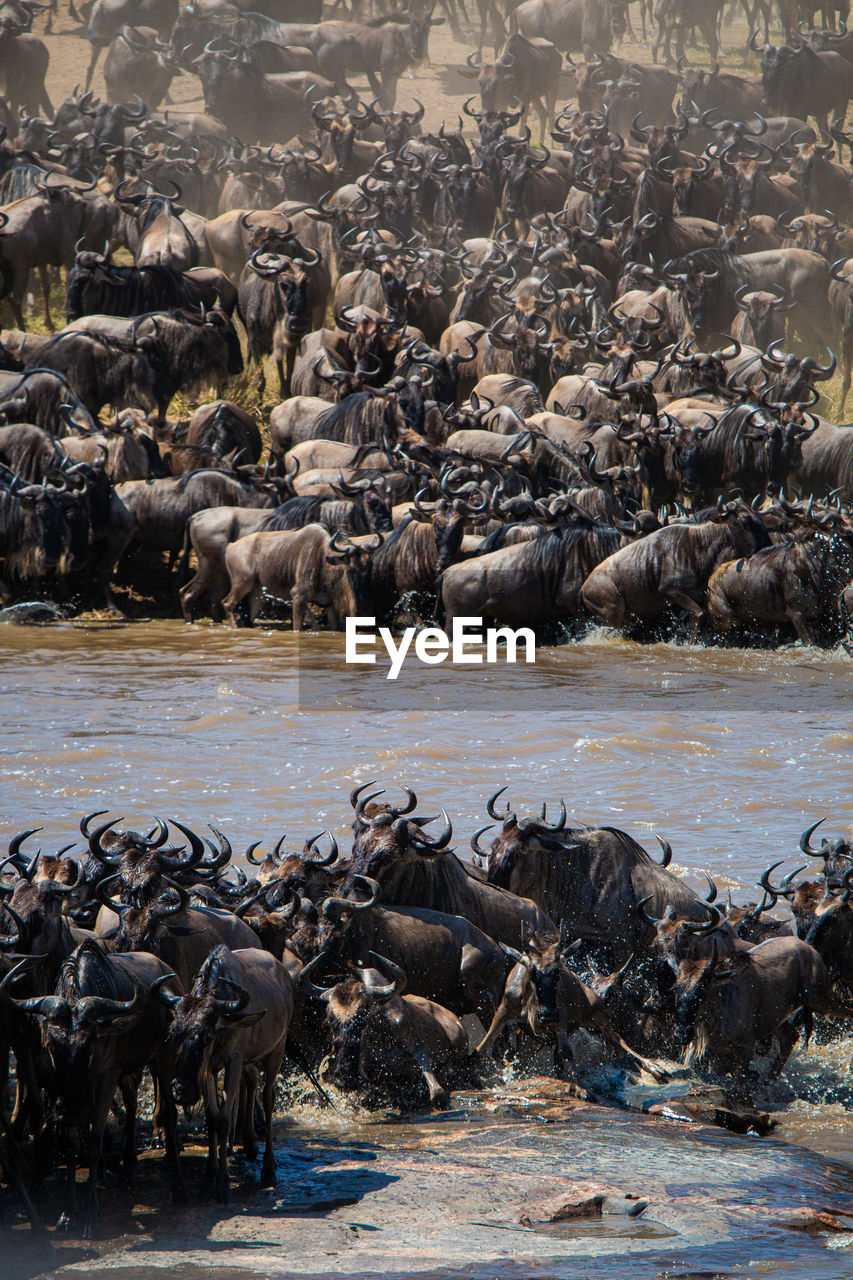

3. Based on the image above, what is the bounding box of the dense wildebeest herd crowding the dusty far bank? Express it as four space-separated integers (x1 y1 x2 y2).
0 0 853 645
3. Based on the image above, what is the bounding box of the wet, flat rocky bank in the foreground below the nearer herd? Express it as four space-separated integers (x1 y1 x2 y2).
9 1079 853 1280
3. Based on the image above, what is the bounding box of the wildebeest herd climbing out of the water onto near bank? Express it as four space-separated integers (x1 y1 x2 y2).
0 783 853 1235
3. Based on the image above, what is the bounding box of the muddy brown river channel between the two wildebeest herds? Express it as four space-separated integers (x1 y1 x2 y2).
0 622 853 888
